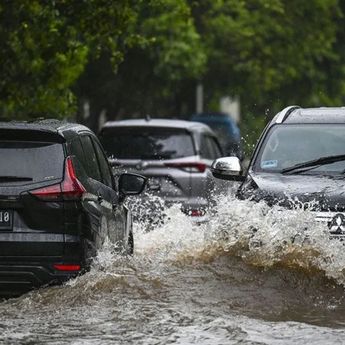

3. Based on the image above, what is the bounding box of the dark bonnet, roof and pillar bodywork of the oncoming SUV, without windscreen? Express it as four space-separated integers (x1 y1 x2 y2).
218 106 345 212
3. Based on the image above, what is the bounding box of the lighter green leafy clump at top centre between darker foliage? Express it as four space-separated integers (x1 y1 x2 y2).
138 0 206 80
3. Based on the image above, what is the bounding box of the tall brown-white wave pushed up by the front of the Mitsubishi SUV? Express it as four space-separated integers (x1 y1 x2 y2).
204 196 345 285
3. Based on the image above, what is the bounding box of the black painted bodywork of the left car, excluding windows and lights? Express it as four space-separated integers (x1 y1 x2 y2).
0 122 142 295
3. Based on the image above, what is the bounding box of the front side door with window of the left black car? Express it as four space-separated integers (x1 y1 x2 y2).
92 137 131 249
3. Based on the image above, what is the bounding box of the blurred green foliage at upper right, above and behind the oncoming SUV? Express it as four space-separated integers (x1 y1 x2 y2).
185 0 345 146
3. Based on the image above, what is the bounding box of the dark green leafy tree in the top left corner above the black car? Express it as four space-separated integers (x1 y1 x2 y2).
0 0 144 118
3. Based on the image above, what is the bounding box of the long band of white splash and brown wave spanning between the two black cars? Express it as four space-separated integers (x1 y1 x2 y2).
121 191 345 285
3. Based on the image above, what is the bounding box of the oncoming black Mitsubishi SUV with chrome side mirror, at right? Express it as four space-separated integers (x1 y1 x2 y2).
211 106 345 240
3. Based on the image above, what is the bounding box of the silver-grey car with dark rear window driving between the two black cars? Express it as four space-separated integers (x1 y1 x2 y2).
99 118 222 222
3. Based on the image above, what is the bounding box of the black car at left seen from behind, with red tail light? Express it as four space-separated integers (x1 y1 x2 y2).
0 121 145 295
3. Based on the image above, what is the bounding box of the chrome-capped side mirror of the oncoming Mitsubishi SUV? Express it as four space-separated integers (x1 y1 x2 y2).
211 157 244 181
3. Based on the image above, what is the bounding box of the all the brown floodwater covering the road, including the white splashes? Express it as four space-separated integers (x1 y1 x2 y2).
0 189 345 345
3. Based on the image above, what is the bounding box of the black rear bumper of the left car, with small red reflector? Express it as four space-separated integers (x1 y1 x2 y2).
0 232 84 296
